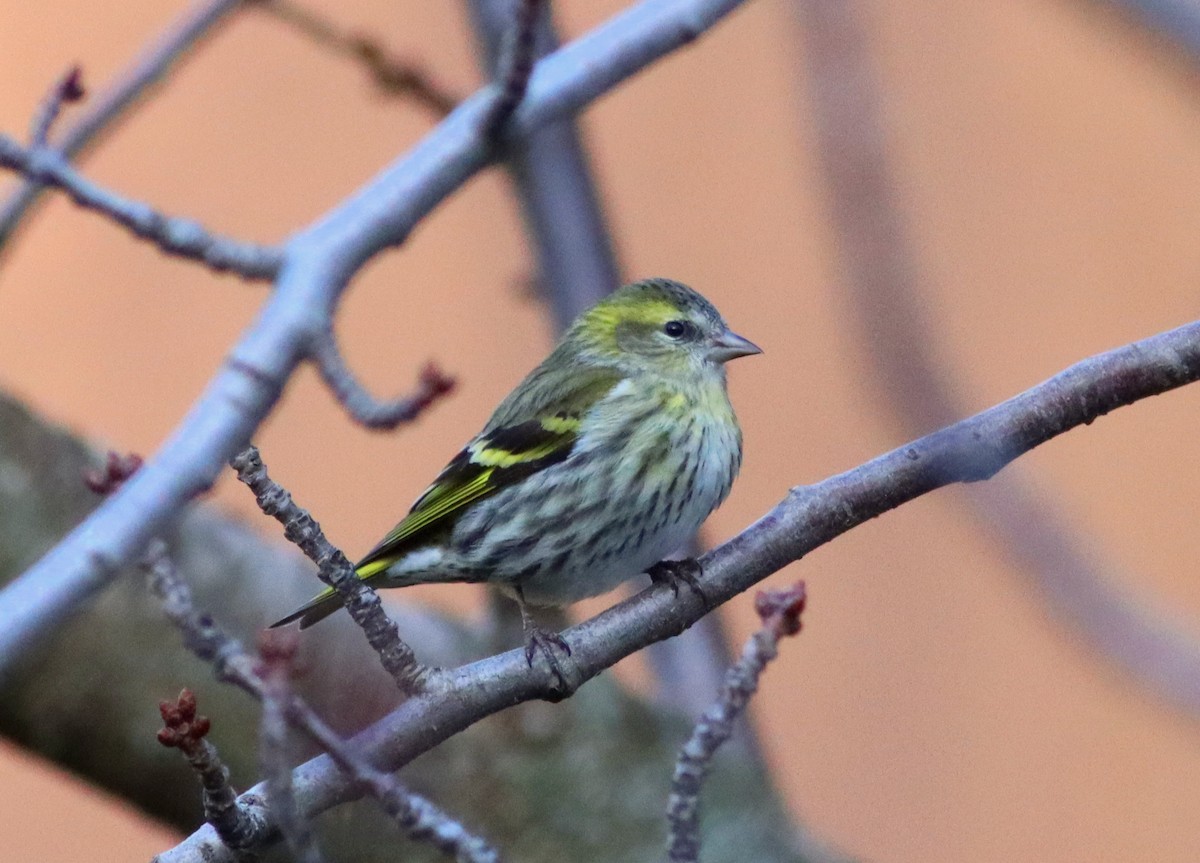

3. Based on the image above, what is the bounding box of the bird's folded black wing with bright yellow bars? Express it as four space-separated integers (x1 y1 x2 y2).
355 368 620 579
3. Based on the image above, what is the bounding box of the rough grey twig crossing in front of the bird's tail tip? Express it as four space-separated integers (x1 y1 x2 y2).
229 447 430 695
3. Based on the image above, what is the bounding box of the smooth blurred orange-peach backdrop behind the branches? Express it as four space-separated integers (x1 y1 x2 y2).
0 0 1200 863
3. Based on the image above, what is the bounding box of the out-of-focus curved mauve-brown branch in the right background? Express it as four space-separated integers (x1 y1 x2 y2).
797 0 1200 713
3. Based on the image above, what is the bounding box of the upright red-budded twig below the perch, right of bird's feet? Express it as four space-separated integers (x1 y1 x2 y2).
667 581 805 863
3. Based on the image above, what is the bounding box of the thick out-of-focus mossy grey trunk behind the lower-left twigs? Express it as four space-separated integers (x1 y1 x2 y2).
0 396 802 863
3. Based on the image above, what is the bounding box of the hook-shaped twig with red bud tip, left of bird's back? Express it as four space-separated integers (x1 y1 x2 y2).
312 330 456 428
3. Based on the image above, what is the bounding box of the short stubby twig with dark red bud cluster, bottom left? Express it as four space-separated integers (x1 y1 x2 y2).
158 689 263 851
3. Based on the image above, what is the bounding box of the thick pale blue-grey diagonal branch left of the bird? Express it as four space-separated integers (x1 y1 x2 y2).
0 0 740 683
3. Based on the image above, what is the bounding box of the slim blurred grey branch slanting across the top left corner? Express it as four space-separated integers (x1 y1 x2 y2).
0 0 241 253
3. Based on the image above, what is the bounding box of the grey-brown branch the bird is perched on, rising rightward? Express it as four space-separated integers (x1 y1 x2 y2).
162 323 1200 863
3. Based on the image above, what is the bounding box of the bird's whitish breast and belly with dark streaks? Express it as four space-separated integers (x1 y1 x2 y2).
452 374 742 605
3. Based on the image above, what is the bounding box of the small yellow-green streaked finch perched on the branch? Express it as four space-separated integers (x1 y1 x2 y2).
274 278 762 671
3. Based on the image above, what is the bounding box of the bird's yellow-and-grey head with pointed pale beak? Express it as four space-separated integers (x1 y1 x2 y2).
564 278 762 374
